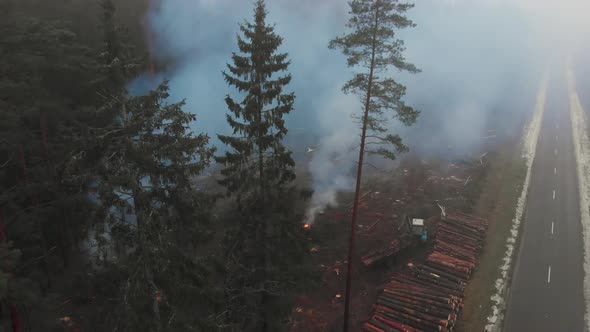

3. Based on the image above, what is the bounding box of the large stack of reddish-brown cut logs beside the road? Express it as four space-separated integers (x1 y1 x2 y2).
363 213 487 332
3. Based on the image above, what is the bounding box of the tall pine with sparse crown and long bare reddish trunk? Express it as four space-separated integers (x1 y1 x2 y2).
329 0 418 331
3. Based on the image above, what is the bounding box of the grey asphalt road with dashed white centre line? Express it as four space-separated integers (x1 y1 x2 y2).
503 73 585 332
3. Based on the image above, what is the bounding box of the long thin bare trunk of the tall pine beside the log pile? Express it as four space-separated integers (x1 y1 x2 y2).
343 7 379 332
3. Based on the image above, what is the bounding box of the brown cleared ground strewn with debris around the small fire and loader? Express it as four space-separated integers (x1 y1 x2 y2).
292 154 490 332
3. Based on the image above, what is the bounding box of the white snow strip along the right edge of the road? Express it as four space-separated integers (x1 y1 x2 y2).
566 58 590 331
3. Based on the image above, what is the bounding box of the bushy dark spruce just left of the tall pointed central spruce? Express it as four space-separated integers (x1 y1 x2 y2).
89 82 220 331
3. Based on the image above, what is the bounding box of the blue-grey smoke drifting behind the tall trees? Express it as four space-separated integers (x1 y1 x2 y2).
130 0 590 223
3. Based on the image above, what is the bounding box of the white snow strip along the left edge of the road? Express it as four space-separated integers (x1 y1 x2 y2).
485 72 548 332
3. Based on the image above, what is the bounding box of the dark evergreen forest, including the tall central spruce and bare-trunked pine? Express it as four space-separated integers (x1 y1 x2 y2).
0 0 426 332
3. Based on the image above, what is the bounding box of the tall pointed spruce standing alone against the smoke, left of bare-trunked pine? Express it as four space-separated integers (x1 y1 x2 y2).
216 0 310 331
